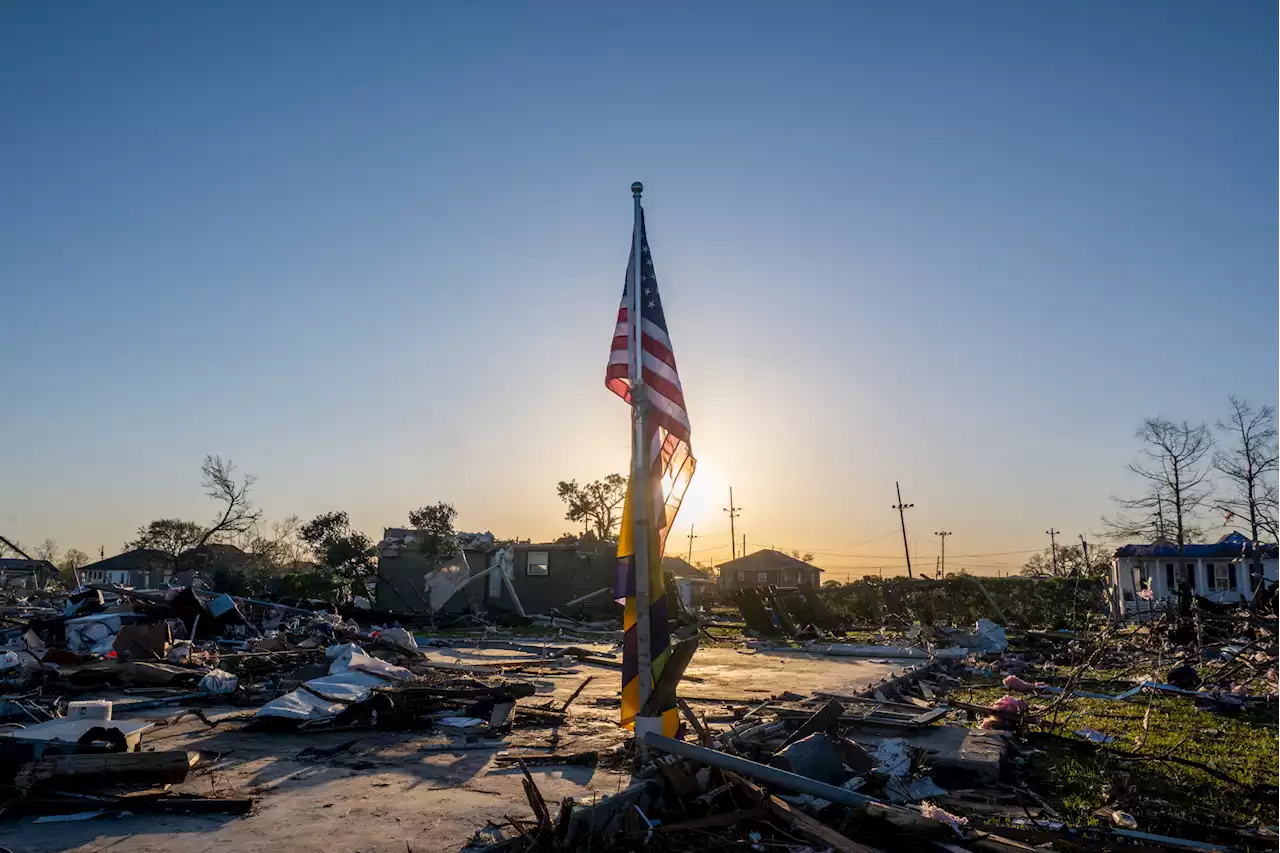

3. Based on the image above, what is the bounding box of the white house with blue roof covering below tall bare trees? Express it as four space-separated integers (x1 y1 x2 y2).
1111 533 1280 613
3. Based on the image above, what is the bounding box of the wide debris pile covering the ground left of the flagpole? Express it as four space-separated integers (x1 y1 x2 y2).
0 573 614 821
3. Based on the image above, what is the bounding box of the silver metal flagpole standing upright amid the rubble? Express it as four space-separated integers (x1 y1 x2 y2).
628 181 653 722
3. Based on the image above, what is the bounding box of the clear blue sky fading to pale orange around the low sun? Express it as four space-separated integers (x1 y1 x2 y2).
0 1 1280 576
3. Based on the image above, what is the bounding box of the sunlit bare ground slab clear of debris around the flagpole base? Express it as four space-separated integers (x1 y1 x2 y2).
0 647 906 853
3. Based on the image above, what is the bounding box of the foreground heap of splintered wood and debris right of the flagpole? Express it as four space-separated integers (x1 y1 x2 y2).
468 590 1280 853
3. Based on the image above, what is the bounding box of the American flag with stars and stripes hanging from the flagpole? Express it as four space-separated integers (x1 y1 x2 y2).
604 211 698 553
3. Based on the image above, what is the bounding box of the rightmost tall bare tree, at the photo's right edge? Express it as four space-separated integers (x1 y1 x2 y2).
1213 397 1280 542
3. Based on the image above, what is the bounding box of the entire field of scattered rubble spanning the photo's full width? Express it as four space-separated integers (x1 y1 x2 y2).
0 571 1280 853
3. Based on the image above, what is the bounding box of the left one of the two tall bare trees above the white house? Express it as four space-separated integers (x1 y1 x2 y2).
1103 418 1213 557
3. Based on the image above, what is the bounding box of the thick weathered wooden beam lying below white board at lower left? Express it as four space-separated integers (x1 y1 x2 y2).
14 749 200 790
